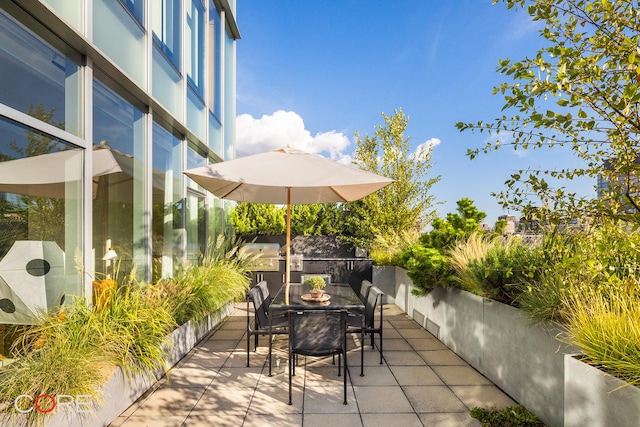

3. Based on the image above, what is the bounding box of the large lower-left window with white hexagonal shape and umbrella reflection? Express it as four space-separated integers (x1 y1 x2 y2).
0 118 84 365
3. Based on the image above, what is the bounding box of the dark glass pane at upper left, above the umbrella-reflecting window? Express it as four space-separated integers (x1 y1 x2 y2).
0 10 81 135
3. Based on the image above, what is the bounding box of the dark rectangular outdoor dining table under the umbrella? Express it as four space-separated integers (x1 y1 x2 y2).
269 283 364 376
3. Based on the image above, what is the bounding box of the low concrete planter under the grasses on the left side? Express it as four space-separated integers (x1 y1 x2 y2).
46 302 234 427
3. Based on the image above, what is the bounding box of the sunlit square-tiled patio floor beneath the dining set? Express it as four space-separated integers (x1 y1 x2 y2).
111 304 515 427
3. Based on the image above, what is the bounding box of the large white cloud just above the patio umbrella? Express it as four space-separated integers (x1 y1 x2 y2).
236 110 350 162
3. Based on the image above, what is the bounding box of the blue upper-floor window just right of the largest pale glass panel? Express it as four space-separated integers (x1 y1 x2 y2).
151 0 181 70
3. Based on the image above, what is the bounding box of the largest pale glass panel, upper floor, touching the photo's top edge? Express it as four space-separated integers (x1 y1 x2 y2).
93 0 147 87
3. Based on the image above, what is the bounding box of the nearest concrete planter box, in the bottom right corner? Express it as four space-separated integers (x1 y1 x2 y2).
564 354 640 427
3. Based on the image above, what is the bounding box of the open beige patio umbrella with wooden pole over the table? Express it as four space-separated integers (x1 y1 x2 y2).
184 148 394 300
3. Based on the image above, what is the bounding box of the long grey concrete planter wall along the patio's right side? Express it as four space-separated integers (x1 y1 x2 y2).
373 267 577 426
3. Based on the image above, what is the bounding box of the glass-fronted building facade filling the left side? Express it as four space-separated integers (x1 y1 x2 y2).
0 0 240 348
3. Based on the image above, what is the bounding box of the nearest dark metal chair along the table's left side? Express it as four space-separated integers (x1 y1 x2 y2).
247 282 289 375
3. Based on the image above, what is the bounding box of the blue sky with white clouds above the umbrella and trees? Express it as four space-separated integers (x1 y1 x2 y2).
236 0 593 225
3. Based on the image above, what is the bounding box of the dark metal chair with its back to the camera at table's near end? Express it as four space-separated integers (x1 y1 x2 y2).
289 310 347 405
